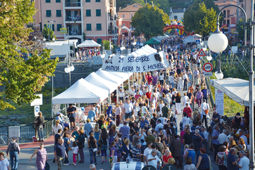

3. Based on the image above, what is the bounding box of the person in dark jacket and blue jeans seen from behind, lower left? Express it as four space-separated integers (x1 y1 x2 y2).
6 137 20 170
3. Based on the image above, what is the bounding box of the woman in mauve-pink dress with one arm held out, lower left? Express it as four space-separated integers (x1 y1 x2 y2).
29 143 47 170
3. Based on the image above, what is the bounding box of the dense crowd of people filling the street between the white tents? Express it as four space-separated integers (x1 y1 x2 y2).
0 39 249 170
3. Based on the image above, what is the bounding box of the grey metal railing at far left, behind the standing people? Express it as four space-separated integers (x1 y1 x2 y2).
0 120 52 145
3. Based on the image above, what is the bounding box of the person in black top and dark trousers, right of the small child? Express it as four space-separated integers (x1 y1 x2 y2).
88 131 97 165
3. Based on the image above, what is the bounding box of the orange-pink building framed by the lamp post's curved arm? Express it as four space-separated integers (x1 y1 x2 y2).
215 0 237 30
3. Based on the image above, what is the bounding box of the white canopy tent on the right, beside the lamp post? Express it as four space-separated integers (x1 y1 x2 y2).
211 78 255 106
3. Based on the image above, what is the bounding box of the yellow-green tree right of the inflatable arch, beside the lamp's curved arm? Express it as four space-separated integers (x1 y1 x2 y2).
183 0 219 36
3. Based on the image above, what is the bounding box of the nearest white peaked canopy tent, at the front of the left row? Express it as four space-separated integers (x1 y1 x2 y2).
52 78 108 104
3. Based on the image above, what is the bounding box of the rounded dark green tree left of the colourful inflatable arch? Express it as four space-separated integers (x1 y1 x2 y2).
131 4 170 40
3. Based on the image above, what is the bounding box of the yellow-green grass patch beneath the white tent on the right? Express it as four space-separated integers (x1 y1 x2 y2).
210 86 244 117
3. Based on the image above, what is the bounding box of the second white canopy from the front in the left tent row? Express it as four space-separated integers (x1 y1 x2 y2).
85 72 118 94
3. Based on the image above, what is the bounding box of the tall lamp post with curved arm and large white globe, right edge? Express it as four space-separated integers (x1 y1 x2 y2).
208 3 255 170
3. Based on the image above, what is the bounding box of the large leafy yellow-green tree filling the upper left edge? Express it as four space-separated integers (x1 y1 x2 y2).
0 0 57 110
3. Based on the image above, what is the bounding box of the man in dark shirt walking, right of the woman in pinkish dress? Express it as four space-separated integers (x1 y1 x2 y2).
54 137 67 170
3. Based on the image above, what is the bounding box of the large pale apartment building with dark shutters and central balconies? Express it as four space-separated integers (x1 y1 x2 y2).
35 0 118 43
